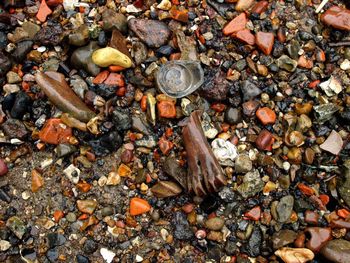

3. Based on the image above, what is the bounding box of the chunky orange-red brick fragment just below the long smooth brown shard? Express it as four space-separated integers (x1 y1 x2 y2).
39 119 72 144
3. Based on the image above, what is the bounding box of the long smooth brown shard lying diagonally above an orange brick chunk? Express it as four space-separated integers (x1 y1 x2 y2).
35 71 95 122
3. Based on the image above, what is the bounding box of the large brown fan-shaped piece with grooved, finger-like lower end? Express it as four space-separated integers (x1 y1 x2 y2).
182 111 226 196
